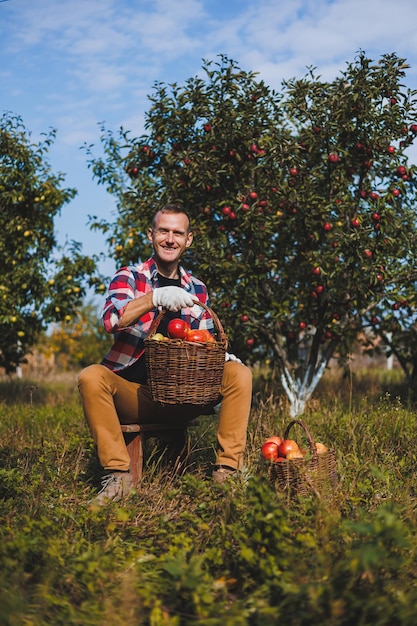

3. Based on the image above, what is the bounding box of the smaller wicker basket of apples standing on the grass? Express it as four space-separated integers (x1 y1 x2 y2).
269 420 337 497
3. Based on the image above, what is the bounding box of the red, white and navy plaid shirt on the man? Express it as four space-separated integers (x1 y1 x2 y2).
101 257 213 372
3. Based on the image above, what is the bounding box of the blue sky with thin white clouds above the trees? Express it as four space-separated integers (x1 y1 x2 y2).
0 0 417 274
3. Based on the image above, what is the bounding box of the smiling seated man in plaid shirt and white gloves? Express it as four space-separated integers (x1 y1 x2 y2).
79 204 252 504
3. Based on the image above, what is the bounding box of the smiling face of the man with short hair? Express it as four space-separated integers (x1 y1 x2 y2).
148 212 193 264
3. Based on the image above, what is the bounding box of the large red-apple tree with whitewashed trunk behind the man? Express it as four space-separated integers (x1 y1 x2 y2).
83 53 417 416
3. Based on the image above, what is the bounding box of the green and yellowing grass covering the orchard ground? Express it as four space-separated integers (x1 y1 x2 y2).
0 370 417 626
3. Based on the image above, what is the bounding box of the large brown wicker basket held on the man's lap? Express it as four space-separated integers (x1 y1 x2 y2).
145 302 227 405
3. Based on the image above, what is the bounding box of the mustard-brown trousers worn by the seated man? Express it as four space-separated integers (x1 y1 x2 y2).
78 361 252 471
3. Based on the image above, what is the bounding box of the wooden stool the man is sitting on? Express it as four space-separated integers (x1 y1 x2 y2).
120 420 198 486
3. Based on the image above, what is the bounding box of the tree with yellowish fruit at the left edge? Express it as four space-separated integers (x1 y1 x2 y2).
0 113 99 373
